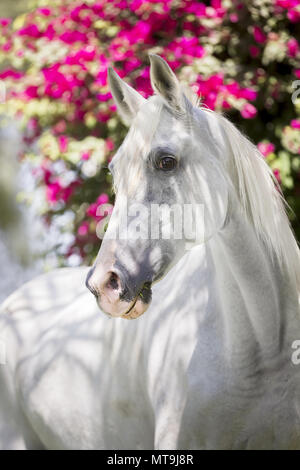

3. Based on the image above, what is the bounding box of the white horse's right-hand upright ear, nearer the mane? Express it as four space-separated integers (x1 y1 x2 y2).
149 54 181 110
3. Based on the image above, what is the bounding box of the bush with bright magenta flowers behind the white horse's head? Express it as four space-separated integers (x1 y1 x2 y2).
0 0 300 262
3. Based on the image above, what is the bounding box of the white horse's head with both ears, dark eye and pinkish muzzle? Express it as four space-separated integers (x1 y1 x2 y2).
87 55 228 318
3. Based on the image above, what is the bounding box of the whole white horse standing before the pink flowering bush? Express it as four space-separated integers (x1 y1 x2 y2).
0 55 300 449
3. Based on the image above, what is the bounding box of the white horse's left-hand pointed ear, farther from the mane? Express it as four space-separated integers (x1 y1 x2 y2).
108 67 146 126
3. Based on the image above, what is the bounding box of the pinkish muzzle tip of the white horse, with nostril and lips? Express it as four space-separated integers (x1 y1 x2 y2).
86 266 148 319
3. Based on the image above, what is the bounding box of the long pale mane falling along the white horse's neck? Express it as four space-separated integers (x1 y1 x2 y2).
198 106 300 290
